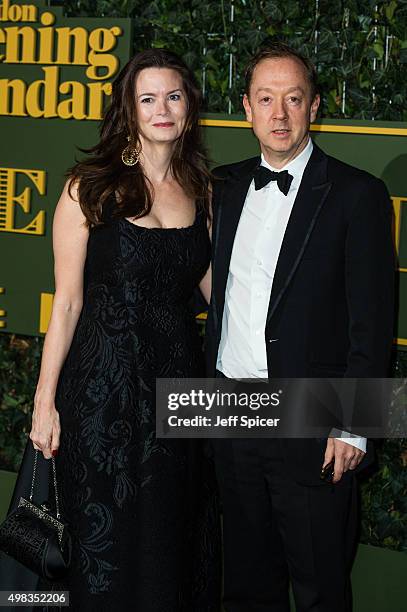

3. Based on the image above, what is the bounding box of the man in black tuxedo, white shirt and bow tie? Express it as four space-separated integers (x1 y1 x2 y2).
206 44 394 612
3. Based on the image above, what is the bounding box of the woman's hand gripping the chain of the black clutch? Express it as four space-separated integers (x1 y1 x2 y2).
30 396 61 459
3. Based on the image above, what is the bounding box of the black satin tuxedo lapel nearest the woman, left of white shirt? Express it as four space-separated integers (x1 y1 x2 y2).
212 161 258 329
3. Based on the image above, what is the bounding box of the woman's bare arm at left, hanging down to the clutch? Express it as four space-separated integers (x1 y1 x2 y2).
30 183 89 459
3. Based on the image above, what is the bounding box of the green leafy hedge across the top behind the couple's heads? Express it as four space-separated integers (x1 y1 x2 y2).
55 0 407 121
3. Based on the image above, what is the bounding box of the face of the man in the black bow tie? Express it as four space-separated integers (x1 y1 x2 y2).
243 57 320 163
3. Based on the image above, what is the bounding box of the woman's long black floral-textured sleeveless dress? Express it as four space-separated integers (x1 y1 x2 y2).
42 203 220 612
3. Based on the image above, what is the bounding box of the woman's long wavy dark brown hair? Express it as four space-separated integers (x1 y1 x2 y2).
68 49 210 226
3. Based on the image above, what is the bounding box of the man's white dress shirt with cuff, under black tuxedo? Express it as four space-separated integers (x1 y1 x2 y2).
216 138 366 452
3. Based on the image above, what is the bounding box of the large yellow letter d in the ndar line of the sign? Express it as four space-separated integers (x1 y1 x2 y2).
26 66 59 119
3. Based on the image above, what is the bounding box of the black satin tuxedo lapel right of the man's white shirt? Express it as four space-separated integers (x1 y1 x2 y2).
267 144 332 323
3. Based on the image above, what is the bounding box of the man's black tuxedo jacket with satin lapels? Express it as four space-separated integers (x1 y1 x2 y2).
205 144 395 484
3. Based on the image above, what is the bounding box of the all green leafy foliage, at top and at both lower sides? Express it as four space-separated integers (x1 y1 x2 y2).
0 0 407 551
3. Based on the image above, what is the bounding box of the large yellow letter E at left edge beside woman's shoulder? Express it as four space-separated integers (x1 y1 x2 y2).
0 168 46 235
